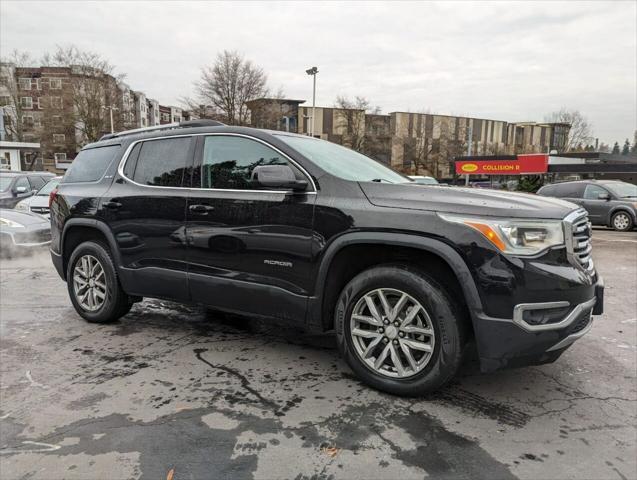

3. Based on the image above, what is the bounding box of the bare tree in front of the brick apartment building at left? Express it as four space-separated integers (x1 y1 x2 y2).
42 45 124 143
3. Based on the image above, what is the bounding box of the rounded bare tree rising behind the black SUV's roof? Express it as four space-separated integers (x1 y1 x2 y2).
189 50 268 125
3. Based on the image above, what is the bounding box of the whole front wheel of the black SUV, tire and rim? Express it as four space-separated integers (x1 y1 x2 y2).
336 265 465 396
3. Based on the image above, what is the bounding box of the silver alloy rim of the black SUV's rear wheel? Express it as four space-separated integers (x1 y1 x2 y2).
73 255 108 312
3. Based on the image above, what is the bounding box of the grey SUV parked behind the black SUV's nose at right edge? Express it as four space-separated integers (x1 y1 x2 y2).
537 180 637 231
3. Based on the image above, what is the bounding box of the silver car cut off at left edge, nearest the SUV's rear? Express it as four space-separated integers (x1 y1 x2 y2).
0 208 51 257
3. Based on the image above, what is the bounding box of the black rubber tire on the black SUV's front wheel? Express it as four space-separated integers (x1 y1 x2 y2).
335 265 466 396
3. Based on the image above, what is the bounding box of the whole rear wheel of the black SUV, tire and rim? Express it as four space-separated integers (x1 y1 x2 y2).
66 241 132 323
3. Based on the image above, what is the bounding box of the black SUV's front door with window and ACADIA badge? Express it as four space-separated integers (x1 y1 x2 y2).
185 134 316 321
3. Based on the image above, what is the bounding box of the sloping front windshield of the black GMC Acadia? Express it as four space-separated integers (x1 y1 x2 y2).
278 135 410 183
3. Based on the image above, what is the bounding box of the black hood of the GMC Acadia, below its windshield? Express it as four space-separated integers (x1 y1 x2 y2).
359 182 579 219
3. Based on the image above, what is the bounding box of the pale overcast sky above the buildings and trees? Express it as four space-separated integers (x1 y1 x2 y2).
0 0 637 143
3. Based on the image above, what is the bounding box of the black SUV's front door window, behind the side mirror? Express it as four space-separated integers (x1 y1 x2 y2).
198 135 296 190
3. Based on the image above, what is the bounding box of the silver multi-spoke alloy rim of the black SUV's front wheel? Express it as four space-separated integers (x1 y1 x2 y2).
350 288 435 378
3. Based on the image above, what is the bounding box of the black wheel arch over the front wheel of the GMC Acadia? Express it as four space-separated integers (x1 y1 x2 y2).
309 232 483 330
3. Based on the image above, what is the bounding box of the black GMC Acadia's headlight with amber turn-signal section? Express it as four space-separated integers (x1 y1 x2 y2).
438 214 564 255
